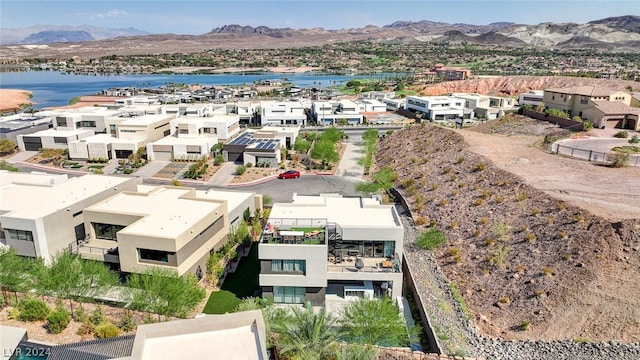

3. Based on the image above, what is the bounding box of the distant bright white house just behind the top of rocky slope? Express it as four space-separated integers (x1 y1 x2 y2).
405 96 464 121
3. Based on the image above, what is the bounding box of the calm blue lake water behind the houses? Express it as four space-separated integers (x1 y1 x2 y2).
0 71 384 109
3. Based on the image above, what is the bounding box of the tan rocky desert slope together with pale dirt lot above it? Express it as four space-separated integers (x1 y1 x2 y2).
377 119 640 342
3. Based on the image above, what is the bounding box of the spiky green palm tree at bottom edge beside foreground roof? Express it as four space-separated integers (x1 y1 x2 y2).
272 308 340 360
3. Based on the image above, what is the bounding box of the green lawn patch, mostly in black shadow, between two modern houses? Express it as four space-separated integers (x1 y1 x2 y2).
203 243 260 314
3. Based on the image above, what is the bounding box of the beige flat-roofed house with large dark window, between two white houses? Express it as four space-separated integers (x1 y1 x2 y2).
73 186 262 275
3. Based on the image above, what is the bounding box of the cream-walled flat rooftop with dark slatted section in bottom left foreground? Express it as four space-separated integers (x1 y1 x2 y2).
0 310 269 360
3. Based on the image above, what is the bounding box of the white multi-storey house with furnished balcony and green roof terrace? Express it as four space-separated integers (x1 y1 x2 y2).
258 194 404 308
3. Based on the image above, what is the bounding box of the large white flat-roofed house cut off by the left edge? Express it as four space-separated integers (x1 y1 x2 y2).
0 171 138 263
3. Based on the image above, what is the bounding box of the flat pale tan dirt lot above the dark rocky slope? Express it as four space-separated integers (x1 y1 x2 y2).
460 121 640 221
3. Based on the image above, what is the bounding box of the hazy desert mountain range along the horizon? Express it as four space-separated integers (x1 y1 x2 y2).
0 15 640 57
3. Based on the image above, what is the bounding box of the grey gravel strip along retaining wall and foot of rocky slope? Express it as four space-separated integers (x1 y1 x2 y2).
402 214 640 360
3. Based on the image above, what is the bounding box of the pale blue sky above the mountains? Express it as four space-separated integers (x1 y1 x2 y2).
0 0 640 35
